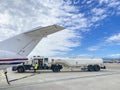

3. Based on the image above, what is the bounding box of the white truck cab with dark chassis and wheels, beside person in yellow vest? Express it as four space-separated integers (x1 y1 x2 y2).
12 56 62 73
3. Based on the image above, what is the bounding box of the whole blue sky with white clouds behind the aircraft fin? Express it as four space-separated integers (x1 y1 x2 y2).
0 0 120 57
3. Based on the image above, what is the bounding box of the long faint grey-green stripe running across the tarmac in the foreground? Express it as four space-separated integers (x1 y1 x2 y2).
0 72 120 90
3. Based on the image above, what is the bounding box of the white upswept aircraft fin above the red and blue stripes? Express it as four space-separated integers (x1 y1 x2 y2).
0 25 64 56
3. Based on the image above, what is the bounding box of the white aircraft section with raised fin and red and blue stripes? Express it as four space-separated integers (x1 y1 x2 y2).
0 25 64 69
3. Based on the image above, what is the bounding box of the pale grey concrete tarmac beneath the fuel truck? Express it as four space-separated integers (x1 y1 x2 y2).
0 64 120 90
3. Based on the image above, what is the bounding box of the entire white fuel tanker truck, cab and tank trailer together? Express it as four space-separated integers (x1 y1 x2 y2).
12 56 106 73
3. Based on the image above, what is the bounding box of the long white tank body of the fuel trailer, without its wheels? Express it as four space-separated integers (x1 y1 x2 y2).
51 58 103 66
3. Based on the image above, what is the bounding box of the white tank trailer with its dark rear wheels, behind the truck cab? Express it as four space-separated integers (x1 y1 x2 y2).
52 58 106 71
